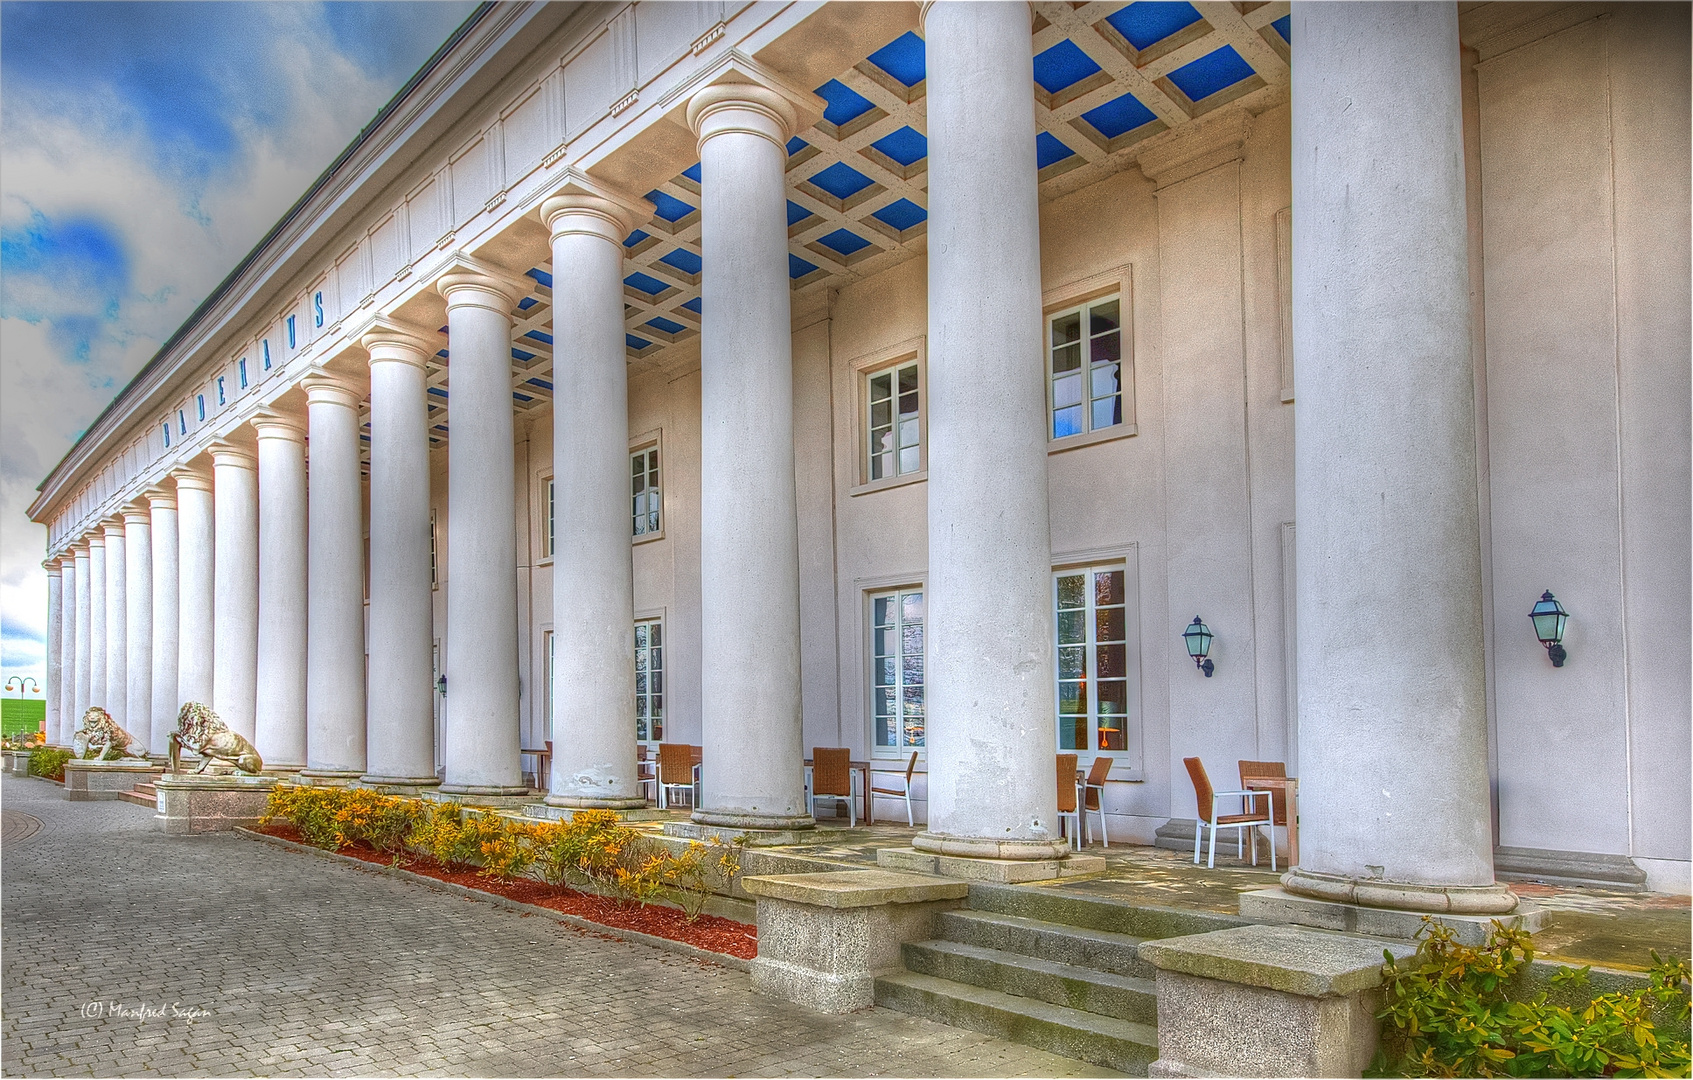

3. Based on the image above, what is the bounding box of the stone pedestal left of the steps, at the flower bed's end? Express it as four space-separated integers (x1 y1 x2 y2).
742 870 970 1012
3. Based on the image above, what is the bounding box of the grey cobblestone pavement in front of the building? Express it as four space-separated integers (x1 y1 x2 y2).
0 777 1114 1077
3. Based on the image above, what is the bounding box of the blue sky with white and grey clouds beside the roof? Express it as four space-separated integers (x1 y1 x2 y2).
0 0 474 690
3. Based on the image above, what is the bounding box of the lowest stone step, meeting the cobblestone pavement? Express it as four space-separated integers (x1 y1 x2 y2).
875 972 1158 1077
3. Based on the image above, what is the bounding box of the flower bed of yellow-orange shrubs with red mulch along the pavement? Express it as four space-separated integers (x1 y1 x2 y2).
259 789 758 960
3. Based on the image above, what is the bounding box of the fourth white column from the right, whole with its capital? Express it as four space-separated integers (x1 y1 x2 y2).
540 179 648 807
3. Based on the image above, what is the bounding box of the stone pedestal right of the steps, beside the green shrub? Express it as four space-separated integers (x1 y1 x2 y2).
1139 926 1417 1077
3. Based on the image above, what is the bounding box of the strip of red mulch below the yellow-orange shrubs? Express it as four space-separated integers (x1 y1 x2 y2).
257 821 758 960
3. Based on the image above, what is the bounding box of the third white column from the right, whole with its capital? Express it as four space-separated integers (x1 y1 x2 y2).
687 85 813 828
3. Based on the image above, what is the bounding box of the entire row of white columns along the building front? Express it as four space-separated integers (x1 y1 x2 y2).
39 3 1514 909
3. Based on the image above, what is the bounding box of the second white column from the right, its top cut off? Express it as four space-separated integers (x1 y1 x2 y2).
913 3 1065 858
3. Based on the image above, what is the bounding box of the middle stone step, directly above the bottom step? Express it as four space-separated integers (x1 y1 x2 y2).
902 941 1158 1026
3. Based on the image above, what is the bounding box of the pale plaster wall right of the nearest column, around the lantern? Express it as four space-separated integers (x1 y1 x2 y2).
1478 5 1690 877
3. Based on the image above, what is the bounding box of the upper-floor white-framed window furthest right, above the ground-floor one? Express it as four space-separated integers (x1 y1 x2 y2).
1046 293 1122 438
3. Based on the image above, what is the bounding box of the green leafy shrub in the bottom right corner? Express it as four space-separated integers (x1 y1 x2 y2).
1366 919 1690 1077
